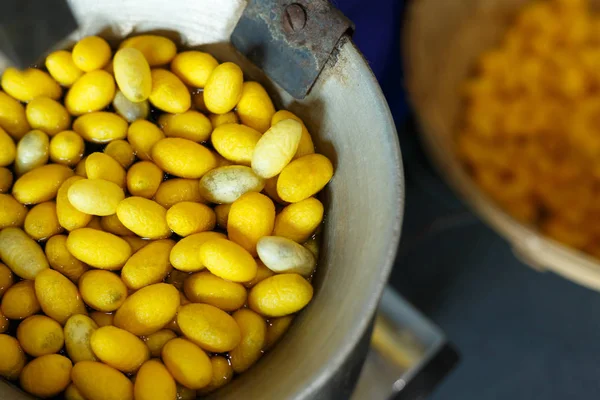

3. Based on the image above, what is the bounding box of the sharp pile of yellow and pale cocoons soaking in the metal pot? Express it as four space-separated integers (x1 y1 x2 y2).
0 35 333 400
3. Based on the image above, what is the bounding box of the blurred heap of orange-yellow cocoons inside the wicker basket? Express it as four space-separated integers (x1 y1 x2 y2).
456 0 600 258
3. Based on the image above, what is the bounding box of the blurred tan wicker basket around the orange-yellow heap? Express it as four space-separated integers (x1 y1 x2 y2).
403 0 600 290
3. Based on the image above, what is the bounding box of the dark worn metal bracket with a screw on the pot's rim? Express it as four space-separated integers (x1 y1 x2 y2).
231 0 354 99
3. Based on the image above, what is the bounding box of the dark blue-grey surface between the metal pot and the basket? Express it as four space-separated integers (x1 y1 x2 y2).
337 0 600 400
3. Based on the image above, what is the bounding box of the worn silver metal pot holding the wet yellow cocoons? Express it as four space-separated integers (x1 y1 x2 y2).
0 0 404 400
